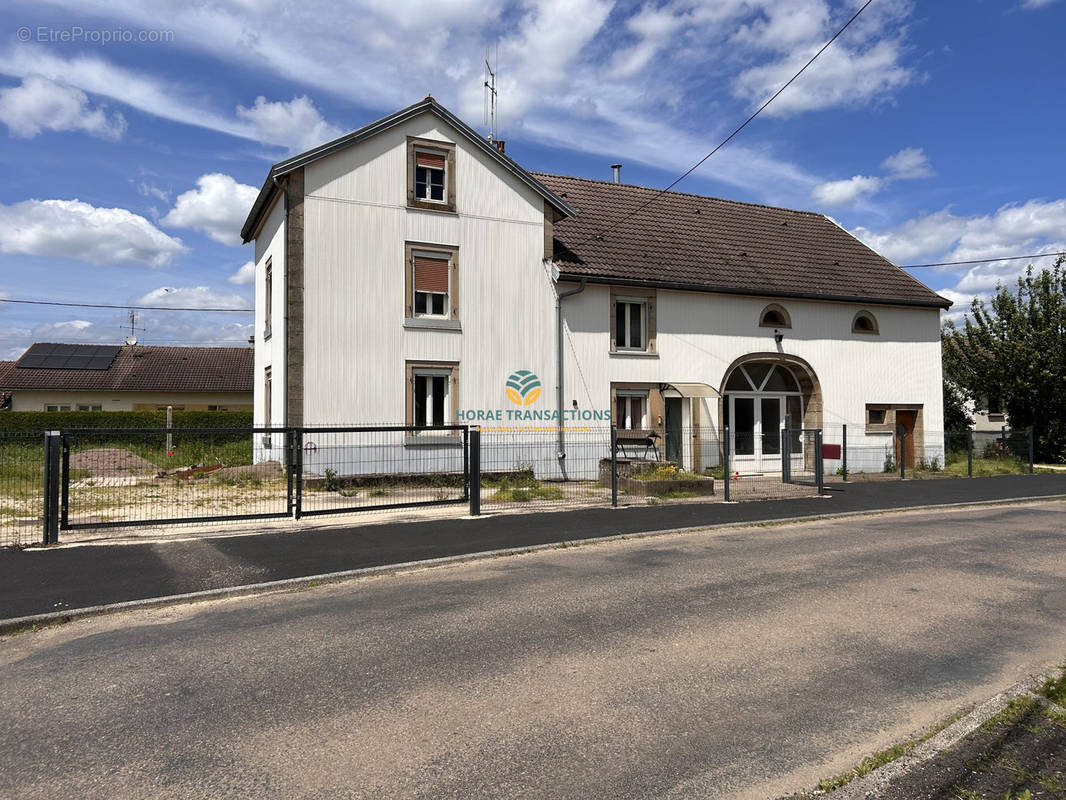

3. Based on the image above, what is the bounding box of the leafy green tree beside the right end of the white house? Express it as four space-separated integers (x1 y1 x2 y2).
941 261 1066 463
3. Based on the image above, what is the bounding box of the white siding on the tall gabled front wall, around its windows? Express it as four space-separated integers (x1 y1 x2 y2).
304 114 554 425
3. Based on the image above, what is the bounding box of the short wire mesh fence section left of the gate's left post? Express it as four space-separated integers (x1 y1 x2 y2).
0 431 45 547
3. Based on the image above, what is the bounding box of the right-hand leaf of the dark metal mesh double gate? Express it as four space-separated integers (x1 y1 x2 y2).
294 426 470 516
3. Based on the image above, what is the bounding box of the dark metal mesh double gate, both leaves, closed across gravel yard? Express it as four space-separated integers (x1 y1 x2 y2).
53 426 470 540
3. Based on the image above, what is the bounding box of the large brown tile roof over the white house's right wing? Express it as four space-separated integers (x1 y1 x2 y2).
533 173 951 308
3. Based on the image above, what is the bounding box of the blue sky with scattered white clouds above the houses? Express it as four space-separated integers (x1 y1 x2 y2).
0 0 1066 357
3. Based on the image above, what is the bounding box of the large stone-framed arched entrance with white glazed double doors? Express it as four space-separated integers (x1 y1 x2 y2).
721 353 822 473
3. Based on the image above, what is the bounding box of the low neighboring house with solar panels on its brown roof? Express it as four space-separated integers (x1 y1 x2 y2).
0 343 253 411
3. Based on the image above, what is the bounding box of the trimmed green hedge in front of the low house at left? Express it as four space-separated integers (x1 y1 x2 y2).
0 411 253 435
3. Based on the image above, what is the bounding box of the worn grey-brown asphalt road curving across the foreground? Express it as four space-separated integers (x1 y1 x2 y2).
0 502 1066 800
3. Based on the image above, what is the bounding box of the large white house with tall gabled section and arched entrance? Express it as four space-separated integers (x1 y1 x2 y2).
242 97 950 470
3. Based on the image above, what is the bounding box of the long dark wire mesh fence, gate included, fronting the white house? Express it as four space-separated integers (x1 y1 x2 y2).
0 426 1033 546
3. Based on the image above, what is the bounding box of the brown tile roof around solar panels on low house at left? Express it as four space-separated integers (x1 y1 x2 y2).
0 345 253 393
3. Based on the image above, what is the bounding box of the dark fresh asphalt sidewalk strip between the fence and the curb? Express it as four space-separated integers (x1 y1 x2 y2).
0 475 1066 620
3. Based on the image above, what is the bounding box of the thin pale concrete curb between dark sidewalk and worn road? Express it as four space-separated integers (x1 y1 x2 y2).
0 494 1066 636
